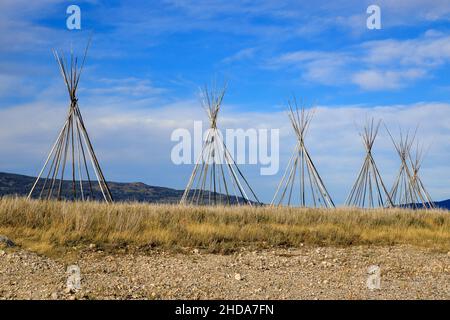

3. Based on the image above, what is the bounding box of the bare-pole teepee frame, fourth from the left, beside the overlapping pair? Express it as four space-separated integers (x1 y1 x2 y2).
345 119 393 208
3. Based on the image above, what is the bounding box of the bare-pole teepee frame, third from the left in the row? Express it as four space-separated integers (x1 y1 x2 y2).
271 98 334 208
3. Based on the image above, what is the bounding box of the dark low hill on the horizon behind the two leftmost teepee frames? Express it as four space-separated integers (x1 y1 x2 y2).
0 172 253 204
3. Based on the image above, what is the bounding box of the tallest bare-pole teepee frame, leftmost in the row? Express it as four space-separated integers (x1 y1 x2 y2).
28 41 113 202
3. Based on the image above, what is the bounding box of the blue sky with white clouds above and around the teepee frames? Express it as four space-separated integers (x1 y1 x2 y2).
0 0 450 203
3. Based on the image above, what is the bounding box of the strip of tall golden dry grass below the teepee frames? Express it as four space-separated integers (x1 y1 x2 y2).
0 198 450 253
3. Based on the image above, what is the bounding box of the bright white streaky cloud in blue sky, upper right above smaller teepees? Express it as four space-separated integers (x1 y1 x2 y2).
268 32 450 90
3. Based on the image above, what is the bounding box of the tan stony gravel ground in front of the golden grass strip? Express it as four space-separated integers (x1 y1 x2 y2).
0 246 450 299
